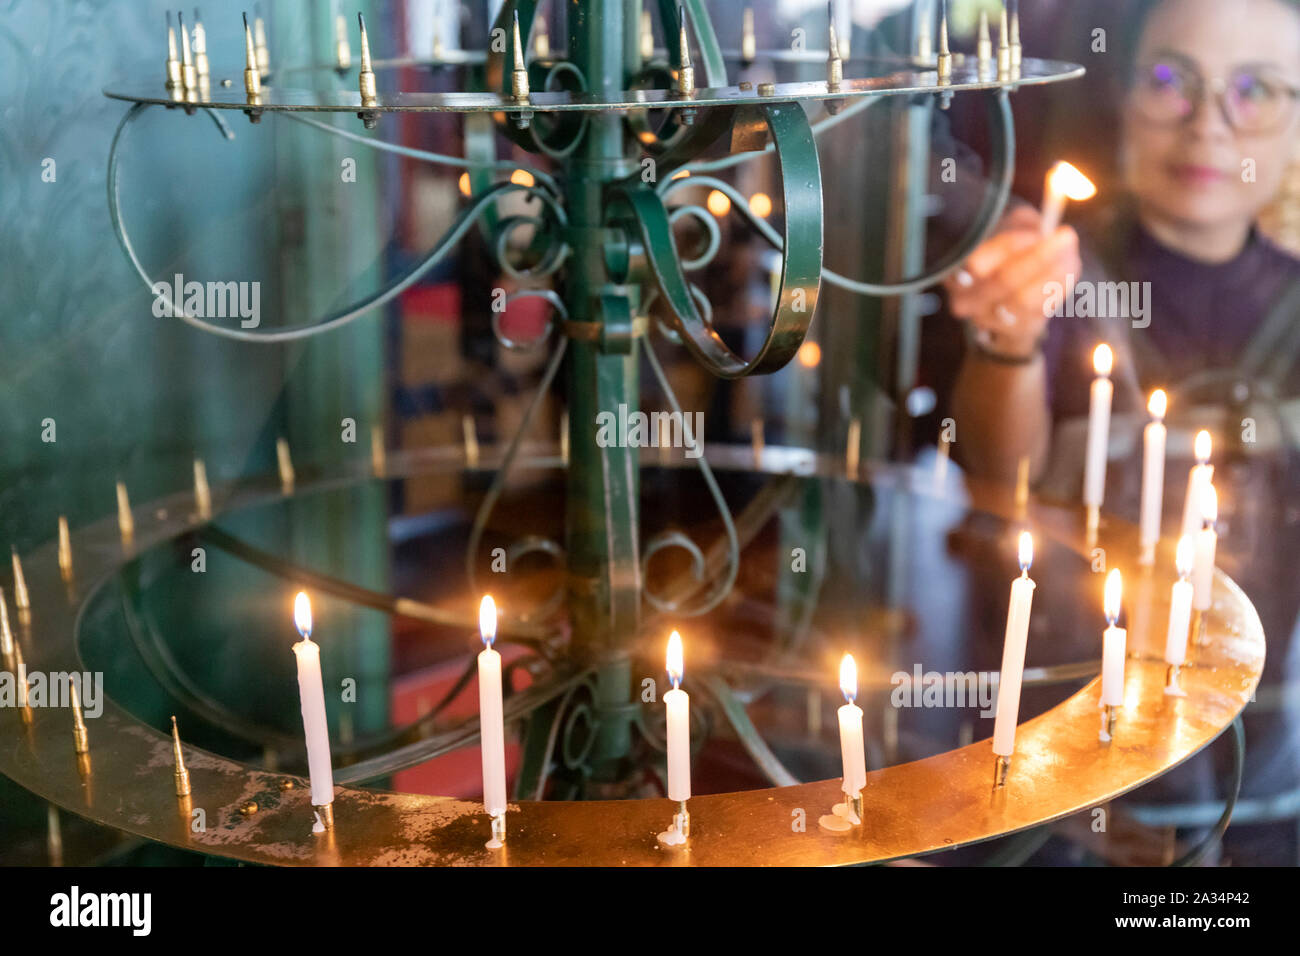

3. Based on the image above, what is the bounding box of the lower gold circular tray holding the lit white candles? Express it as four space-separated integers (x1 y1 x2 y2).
0 446 1265 866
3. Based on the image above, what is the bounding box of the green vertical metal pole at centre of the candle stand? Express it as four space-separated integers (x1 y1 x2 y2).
564 0 641 780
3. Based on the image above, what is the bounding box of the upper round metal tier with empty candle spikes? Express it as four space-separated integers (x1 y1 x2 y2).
104 59 1084 113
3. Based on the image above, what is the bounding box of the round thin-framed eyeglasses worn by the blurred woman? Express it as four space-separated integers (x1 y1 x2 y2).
1132 60 1300 134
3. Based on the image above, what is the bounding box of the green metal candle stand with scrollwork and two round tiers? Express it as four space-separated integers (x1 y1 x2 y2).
0 0 1262 865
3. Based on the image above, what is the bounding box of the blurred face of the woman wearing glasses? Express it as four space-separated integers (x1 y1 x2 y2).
1125 0 1300 229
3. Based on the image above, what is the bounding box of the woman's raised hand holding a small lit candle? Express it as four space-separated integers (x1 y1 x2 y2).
944 206 1083 359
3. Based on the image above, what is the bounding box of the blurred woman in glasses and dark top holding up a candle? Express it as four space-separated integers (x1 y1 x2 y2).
946 0 1300 864
